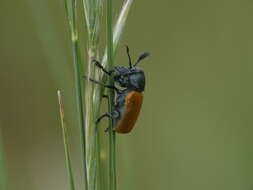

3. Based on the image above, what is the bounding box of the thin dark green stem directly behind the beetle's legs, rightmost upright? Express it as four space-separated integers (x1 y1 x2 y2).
106 0 116 190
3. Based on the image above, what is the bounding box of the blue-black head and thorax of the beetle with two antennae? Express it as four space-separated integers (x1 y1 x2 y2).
114 46 149 92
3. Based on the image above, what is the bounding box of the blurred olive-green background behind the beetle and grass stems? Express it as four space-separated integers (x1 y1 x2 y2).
0 0 253 190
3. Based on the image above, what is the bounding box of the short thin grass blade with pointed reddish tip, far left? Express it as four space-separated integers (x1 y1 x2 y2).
57 90 75 190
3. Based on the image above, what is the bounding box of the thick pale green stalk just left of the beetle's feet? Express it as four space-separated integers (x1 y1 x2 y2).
83 0 103 190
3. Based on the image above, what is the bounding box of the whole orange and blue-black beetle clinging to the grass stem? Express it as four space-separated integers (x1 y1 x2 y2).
90 46 149 133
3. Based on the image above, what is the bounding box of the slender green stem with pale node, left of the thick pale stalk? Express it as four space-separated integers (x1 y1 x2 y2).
65 0 87 189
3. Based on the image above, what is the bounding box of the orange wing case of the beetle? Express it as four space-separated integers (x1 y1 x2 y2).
115 91 143 133
